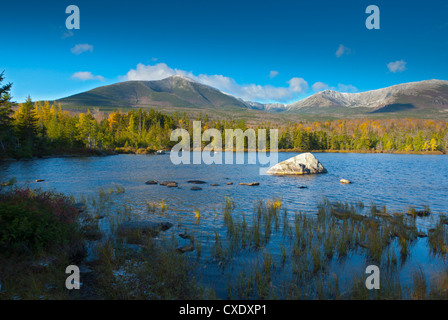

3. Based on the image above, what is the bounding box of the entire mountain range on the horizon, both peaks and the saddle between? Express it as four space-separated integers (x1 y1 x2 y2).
56 75 448 119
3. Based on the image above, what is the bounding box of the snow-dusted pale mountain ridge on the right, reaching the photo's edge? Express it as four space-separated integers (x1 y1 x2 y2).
286 80 448 114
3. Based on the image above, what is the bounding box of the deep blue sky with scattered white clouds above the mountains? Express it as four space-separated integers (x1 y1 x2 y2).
0 0 448 102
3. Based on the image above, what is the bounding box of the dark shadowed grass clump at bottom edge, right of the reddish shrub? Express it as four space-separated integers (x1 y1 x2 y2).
95 236 210 299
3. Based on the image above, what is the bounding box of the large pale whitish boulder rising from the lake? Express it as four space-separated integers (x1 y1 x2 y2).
266 152 327 175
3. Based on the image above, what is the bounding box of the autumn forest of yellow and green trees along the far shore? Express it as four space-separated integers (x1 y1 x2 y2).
0 73 448 158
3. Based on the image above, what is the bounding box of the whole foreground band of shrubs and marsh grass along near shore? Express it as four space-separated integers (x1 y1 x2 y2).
0 184 448 300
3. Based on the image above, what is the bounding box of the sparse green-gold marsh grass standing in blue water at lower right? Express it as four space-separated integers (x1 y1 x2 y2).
208 199 448 299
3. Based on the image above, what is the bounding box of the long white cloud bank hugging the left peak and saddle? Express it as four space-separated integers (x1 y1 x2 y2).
120 63 308 102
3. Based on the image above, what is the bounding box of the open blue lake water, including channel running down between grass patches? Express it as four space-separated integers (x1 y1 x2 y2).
0 153 448 298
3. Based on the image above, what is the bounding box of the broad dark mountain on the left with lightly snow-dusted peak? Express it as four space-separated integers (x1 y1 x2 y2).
57 75 258 110
